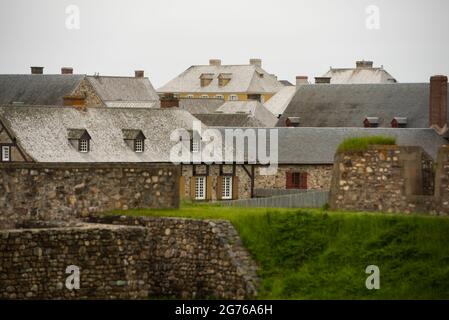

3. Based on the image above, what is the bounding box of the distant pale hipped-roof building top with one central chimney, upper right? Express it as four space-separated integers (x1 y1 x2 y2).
316 60 397 84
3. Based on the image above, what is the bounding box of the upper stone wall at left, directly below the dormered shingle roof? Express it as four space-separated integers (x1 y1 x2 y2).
0 163 179 228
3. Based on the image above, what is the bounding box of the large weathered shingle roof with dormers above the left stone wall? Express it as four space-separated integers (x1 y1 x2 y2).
0 106 196 162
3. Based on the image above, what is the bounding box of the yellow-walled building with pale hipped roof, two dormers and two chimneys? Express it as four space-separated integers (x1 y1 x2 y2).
158 59 284 103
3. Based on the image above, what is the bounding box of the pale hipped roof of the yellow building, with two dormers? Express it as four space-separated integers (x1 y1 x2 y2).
158 65 284 93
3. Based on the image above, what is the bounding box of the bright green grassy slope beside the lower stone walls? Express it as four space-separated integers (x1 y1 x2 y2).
103 205 449 299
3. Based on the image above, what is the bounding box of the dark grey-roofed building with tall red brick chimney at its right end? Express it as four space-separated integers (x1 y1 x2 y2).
277 76 448 129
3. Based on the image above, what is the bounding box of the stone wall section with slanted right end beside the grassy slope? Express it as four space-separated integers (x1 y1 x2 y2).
88 216 258 299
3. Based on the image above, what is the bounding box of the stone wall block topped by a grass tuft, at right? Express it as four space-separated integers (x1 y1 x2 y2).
330 146 438 213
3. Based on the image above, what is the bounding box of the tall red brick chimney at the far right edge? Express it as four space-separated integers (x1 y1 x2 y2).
429 76 447 131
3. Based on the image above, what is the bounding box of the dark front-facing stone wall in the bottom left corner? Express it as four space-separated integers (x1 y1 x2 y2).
0 224 151 299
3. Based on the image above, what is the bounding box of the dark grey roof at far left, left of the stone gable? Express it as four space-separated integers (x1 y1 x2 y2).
0 74 84 105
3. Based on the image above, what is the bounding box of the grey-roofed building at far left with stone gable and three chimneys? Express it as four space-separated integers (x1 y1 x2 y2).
0 67 160 108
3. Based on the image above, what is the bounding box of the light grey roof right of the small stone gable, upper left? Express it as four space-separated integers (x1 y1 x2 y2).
87 76 159 101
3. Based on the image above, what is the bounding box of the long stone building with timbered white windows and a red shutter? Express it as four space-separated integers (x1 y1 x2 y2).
180 128 446 201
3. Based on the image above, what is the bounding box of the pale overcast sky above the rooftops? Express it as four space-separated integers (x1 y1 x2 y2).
0 0 449 87
